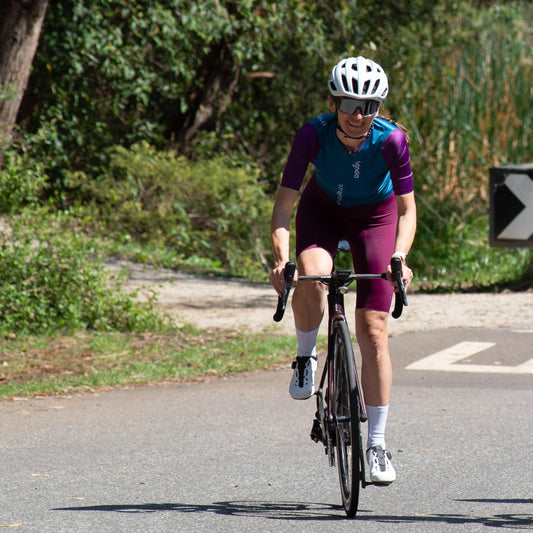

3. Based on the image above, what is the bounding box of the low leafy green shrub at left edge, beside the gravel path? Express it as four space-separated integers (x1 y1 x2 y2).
0 211 170 334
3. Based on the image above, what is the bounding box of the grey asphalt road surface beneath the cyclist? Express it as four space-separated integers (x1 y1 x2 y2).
0 329 533 533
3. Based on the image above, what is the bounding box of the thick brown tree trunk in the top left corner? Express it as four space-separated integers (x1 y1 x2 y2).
0 0 48 152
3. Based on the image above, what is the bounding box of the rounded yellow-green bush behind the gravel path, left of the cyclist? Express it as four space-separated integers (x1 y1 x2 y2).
73 144 271 275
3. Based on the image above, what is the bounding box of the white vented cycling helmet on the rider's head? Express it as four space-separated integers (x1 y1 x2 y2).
328 56 389 102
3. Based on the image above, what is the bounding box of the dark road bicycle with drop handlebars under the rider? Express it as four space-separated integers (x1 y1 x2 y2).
274 245 407 517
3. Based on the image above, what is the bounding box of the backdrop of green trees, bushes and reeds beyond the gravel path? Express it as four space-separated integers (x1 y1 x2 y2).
0 0 533 336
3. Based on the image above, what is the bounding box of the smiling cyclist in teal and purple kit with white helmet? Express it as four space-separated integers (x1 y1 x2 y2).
270 56 416 484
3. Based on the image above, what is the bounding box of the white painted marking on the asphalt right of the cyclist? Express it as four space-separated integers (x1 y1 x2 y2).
406 341 533 374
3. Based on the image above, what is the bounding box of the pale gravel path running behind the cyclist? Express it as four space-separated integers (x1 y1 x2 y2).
106 261 533 335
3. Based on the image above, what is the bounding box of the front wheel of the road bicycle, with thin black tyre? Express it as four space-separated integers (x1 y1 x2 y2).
333 320 364 517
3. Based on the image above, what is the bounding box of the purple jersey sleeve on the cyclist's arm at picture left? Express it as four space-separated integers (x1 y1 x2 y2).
281 124 320 191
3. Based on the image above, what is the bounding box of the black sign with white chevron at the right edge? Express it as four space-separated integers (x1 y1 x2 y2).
490 164 533 247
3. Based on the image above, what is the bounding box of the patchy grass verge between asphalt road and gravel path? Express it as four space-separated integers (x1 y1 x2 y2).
0 326 306 399
